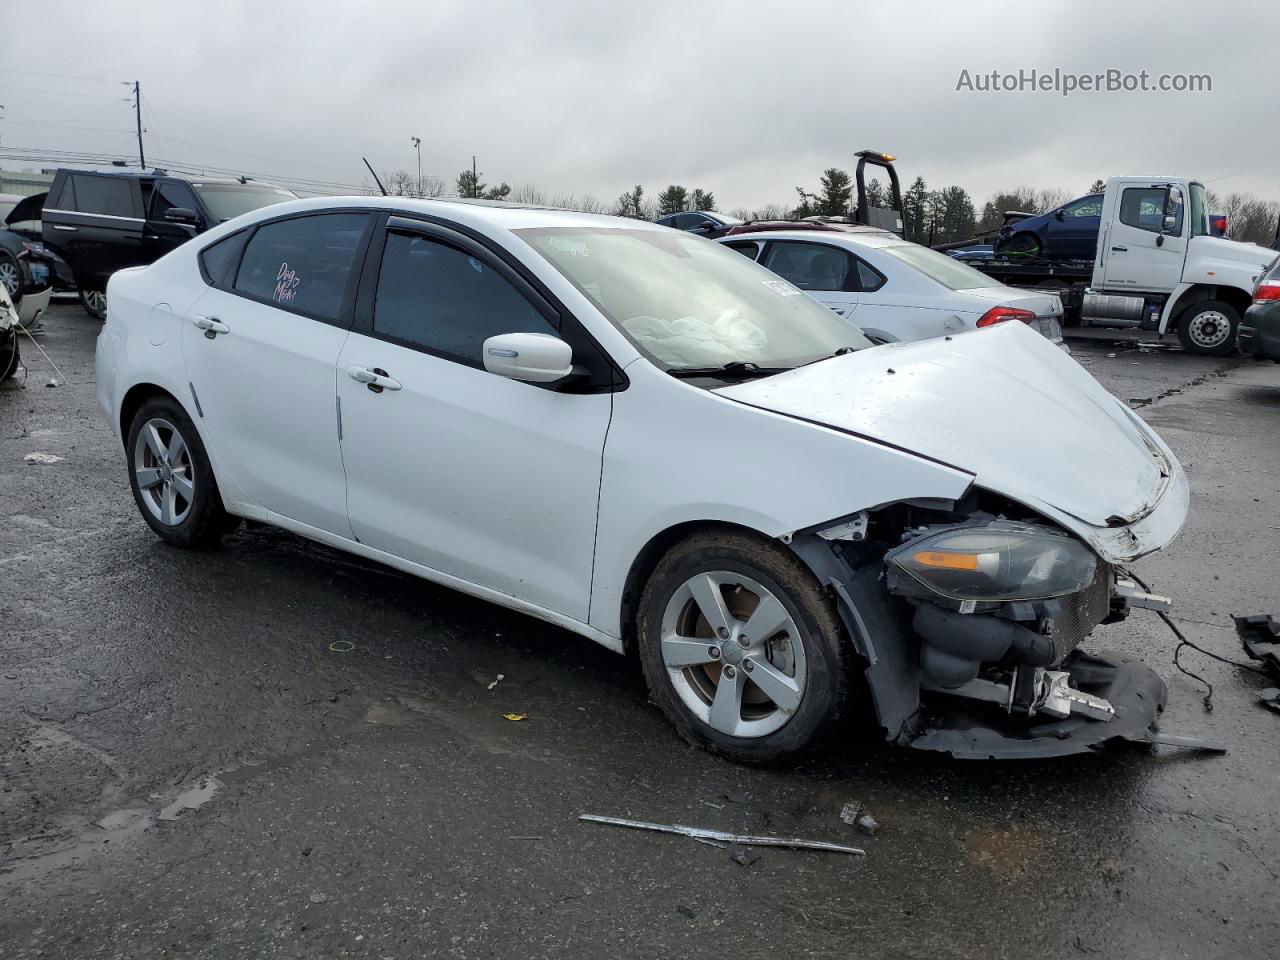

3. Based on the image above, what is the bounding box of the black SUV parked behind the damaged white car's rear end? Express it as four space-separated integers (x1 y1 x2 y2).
42 169 297 320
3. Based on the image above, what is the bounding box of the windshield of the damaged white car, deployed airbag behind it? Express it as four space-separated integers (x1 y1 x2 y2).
516 227 872 371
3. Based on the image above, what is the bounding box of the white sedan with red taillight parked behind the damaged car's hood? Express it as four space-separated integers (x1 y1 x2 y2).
721 230 1062 343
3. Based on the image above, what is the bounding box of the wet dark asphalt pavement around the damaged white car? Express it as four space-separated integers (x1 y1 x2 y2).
0 303 1280 960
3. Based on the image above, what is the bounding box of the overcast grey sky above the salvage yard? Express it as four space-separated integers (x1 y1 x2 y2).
0 0 1280 210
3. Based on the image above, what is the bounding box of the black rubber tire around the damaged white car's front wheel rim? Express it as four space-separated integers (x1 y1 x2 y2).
636 532 852 764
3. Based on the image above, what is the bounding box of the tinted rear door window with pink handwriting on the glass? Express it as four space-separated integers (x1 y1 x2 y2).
236 214 369 320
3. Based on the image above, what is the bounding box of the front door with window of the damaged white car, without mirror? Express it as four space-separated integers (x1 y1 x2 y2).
338 221 612 622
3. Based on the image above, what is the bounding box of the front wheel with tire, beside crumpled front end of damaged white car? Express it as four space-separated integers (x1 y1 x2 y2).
636 532 849 763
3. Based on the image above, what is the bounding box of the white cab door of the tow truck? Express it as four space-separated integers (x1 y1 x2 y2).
1103 183 1188 293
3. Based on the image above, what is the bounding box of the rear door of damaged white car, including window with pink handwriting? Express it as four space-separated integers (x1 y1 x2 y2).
182 210 370 538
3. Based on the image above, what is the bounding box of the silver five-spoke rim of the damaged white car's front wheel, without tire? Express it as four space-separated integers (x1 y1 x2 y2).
662 570 805 739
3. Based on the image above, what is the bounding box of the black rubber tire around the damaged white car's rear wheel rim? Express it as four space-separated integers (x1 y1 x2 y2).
125 397 232 547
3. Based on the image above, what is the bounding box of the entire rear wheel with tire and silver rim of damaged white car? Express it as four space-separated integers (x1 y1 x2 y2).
128 397 228 547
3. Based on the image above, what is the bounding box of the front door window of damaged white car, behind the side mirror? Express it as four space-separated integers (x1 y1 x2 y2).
374 233 559 367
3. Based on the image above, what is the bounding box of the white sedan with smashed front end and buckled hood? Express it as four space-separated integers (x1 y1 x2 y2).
97 197 1188 763
